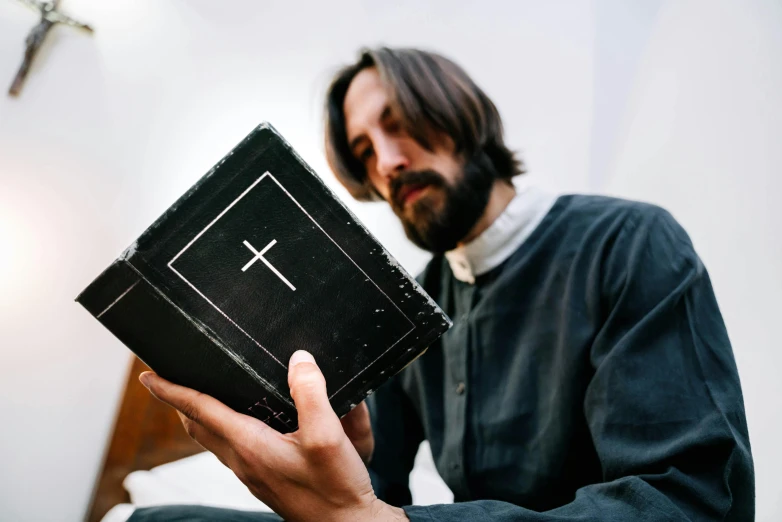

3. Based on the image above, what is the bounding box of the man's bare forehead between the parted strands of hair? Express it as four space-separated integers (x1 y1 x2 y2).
342 67 388 142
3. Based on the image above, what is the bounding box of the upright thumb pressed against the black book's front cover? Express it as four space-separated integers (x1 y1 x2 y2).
288 350 341 434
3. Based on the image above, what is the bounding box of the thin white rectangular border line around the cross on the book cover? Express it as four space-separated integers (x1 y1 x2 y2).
168 171 415 399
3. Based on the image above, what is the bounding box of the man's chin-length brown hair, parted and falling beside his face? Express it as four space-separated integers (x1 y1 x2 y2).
325 47 524 200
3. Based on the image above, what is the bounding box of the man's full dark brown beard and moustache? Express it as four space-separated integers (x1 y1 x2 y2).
390 149 497 254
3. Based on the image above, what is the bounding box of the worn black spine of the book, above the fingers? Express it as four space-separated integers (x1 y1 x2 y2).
76 259 297 433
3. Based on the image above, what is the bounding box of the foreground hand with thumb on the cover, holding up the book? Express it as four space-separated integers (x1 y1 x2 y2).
139 350 407 522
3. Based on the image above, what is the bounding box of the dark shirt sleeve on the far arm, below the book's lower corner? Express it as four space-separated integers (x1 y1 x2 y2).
367 368 424 507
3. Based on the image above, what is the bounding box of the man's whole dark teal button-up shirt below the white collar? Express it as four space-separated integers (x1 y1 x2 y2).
369 196 754 522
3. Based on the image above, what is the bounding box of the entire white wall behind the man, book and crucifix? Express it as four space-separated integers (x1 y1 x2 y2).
0 0 782 521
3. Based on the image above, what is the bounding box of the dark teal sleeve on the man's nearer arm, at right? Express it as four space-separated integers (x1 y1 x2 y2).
404 207 754 522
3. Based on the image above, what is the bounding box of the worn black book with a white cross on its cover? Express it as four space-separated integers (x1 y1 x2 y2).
76 123 451 432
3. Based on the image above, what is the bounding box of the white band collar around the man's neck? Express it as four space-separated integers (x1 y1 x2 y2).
445 182 557 284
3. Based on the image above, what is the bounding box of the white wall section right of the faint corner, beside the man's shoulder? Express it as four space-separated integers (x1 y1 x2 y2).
603 0 782 521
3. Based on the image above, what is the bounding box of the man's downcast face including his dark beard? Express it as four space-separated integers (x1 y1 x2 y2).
343 68 492 252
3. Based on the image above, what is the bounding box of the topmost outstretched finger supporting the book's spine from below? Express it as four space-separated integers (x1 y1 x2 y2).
139 372 262 440
